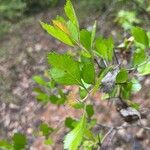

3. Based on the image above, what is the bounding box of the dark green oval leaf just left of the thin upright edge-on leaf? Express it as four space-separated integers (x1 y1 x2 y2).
80 29 91 50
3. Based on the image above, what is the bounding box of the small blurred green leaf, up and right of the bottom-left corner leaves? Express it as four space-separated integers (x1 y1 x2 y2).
39 123 54 138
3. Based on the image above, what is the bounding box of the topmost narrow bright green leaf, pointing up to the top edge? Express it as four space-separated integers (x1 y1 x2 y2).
64 0 79 28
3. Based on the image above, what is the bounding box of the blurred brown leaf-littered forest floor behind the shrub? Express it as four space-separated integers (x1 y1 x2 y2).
0 1 150 150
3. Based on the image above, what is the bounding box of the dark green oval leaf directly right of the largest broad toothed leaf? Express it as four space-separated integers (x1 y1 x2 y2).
82 59 95 84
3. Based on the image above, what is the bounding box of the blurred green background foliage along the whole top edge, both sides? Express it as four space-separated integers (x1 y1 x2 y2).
0 0 150 36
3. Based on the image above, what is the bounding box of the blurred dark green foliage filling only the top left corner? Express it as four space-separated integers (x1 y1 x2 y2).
0 0 61 36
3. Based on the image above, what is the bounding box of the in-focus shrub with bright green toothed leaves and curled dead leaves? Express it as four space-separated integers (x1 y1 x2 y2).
33 0 150 150
